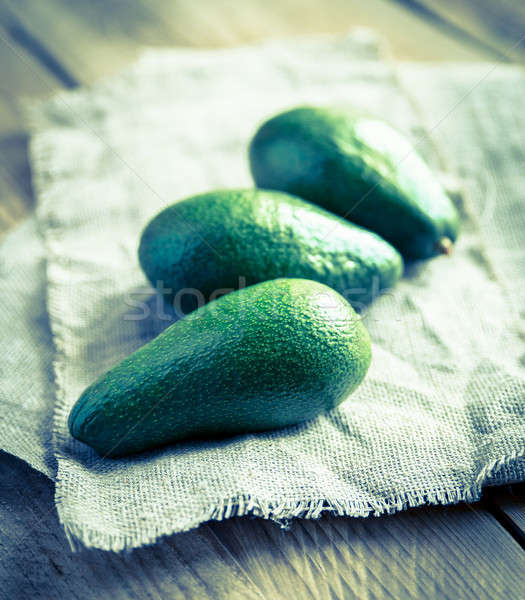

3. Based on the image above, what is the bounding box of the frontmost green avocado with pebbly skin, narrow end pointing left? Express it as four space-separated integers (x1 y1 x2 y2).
69 279 370 457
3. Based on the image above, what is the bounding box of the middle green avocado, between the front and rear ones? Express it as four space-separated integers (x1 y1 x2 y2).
139 189 403 314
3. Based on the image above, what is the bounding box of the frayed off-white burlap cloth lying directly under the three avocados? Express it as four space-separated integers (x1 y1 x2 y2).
2 34 525 550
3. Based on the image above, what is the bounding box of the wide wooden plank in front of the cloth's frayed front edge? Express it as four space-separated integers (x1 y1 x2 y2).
0 454 525 600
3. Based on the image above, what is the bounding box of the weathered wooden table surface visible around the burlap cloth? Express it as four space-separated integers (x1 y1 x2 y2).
0 0 525 600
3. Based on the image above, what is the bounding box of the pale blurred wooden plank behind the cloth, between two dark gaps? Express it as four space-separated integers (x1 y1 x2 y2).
4 0 491 88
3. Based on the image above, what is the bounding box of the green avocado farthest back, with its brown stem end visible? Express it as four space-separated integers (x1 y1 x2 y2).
249 107 459 259
